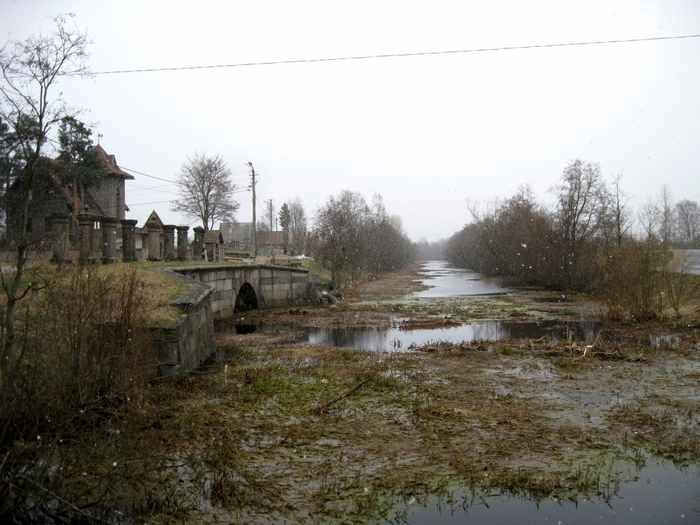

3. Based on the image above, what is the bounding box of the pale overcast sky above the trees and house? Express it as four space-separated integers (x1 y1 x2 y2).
0 0 700 241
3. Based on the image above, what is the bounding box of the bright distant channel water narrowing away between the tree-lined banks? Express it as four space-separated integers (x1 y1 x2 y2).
413 261 510 297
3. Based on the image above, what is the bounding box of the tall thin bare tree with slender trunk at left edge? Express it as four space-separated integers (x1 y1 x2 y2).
0 16 90 375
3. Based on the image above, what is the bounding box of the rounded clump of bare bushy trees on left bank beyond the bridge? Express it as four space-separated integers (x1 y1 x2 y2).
307 190 414 288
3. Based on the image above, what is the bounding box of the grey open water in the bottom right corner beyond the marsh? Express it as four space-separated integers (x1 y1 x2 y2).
384 459 700 525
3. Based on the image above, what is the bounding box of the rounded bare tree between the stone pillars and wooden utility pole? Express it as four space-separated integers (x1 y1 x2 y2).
170 152 240 230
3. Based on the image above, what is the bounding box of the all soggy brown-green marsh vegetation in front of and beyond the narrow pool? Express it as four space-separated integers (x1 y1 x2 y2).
0 265 700 523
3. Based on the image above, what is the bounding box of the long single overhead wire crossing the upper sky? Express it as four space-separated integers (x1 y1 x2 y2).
90 34 700 75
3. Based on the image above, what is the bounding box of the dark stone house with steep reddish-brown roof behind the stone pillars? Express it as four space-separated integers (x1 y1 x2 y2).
7 144 134 241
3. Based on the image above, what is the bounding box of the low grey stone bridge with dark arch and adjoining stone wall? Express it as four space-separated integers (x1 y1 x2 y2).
154 264 321 376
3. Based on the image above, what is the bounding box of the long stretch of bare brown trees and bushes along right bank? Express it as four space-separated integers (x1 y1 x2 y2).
445 159 700 318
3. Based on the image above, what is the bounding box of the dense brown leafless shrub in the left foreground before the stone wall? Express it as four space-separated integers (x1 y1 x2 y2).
0 267 155 522
